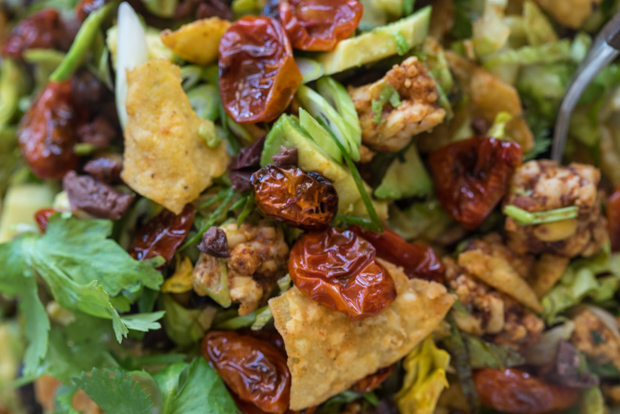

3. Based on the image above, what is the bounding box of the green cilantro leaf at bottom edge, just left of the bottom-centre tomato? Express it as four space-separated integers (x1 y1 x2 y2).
154 358 239 414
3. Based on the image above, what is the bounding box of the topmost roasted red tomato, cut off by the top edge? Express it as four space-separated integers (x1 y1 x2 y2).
279 0 364 51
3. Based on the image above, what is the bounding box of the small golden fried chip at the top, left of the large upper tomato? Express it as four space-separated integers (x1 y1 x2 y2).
160 17 230 66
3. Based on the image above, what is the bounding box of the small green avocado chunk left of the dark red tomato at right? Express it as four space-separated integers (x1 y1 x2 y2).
375 145 433 200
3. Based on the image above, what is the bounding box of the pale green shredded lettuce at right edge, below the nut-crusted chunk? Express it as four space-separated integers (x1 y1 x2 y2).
541 246 620 324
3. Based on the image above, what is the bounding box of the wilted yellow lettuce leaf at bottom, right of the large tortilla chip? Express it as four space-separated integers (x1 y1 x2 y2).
395 336 450 414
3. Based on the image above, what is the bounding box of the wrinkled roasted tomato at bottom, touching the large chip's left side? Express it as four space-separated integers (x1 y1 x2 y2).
202 331 291 414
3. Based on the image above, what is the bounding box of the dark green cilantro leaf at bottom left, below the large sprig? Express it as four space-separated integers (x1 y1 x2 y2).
73 368 153 414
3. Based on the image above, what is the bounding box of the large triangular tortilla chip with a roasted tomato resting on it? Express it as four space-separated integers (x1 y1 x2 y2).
269 260 454 410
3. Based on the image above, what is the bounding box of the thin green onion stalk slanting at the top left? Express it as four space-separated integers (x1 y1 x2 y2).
50 1 117 82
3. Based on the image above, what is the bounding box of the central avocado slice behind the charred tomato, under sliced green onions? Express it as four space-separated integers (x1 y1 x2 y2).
261 114 387 220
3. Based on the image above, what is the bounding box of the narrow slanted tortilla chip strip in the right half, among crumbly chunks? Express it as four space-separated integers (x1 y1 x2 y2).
458 250 542 313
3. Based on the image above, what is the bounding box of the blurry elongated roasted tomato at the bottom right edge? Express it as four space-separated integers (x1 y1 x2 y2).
474 368 579 414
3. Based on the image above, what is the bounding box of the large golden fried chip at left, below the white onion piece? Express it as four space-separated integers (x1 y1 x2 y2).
122 59 230 214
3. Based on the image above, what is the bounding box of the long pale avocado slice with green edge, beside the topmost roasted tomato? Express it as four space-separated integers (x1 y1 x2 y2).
315 6 431 75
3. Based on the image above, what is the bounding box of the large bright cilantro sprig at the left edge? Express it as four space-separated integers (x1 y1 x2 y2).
0 214 163 376
